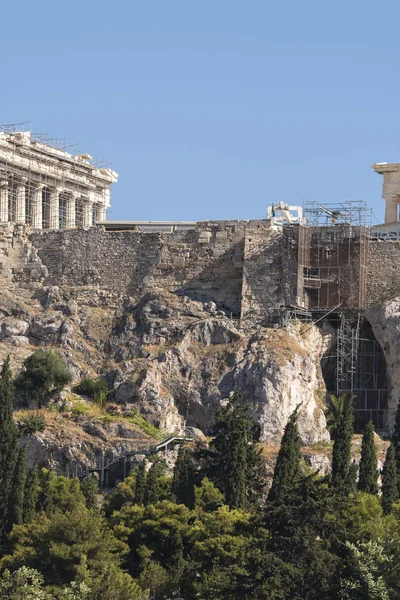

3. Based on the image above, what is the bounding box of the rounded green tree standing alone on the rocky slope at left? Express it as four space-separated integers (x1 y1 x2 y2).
15 350 72 407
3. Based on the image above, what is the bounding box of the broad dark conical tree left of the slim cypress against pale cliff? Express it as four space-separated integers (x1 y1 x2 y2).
205 394 262 508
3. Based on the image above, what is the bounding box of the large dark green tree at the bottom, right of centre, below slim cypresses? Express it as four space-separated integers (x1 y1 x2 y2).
258 473 349 600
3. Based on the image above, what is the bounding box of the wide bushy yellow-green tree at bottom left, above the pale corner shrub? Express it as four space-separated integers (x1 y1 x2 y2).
0 506 142 600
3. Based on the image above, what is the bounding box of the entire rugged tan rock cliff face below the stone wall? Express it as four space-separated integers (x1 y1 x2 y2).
0 278 329 462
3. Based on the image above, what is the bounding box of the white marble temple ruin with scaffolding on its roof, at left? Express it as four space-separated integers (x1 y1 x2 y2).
0 132 118 229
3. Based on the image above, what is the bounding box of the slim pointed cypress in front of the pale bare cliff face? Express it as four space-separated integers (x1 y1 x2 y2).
268 408 301 503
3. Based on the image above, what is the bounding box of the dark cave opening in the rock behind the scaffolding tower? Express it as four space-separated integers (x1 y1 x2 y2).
321 315 389 433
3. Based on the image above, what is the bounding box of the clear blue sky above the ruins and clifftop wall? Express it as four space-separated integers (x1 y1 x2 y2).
0 0 400 220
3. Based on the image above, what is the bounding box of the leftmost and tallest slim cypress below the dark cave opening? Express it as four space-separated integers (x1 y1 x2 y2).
332 397 354 494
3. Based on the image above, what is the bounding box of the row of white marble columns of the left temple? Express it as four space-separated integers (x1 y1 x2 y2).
0 181 106 229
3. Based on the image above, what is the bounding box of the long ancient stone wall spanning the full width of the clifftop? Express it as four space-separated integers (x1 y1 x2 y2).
0 220 400 319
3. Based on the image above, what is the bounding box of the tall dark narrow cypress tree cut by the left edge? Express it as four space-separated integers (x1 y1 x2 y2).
0 357 18 541
